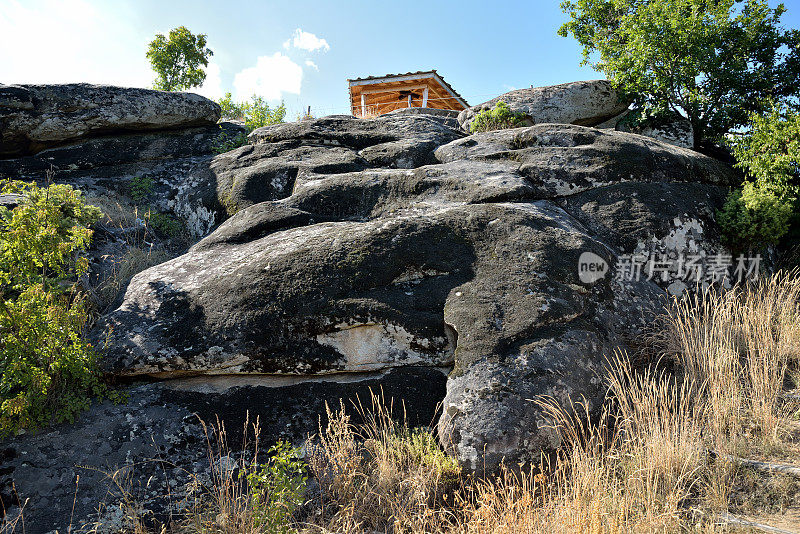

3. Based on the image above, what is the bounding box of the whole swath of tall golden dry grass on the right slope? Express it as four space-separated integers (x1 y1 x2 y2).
459 273 800 534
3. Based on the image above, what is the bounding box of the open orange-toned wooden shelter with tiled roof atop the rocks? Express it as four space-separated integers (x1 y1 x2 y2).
347 70 469 117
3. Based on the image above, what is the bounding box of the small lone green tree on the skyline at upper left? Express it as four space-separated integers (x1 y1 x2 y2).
147 26 214 91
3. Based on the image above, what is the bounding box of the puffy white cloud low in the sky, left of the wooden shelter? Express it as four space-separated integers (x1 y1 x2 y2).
233 52 303 100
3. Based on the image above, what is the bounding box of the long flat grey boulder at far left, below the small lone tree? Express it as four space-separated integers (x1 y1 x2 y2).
0 83 220 157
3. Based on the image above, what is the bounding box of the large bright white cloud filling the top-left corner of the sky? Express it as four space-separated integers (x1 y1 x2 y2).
0 0 153 87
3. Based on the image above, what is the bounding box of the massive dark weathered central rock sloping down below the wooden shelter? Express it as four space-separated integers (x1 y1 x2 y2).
98 120 736 470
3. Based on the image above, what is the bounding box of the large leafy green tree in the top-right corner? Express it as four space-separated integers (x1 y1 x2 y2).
559 0 800 147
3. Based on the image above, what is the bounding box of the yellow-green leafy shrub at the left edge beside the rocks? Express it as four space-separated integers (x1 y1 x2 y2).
0 182 105 437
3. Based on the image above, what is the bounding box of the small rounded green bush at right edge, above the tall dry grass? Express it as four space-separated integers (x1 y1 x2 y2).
717 182 794 251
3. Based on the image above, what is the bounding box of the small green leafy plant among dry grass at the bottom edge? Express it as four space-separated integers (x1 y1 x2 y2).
247 441 308 532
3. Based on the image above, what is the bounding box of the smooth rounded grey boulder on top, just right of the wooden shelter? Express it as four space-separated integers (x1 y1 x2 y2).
458 80 630 131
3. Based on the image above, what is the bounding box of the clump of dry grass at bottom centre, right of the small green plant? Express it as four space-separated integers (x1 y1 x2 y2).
307 394 460 533
